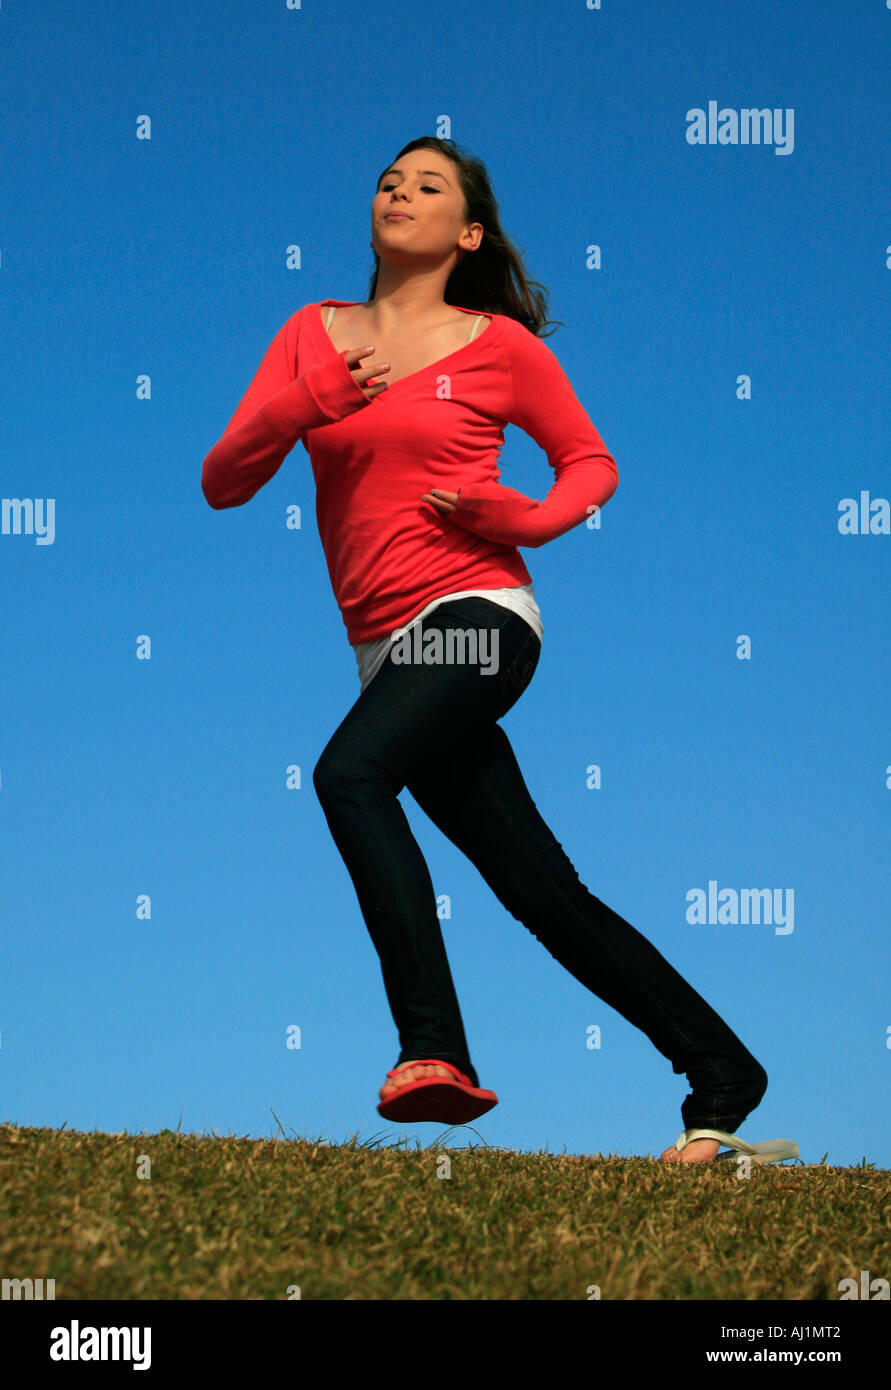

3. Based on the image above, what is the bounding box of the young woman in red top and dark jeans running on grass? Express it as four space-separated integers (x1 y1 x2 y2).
202 138 767 1162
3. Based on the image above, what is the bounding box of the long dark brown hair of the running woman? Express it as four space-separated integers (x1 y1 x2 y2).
368 135 566 338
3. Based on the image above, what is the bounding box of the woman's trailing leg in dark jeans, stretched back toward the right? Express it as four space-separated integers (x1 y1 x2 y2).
407 723 767 1133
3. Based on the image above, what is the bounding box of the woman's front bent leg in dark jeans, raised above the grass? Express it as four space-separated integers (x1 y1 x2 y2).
313 599 530 1086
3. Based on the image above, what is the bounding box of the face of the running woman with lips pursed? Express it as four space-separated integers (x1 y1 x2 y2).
371 149 484 264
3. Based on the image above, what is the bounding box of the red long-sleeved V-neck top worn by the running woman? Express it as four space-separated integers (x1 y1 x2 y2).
202 299 619 644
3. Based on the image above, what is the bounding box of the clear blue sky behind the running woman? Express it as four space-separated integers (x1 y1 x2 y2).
0 0 891 1166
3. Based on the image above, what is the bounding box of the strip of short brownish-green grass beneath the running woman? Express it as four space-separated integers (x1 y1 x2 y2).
0 1123 891 1301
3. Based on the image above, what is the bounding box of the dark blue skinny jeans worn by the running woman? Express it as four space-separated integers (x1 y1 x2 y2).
313 598 767 1133
